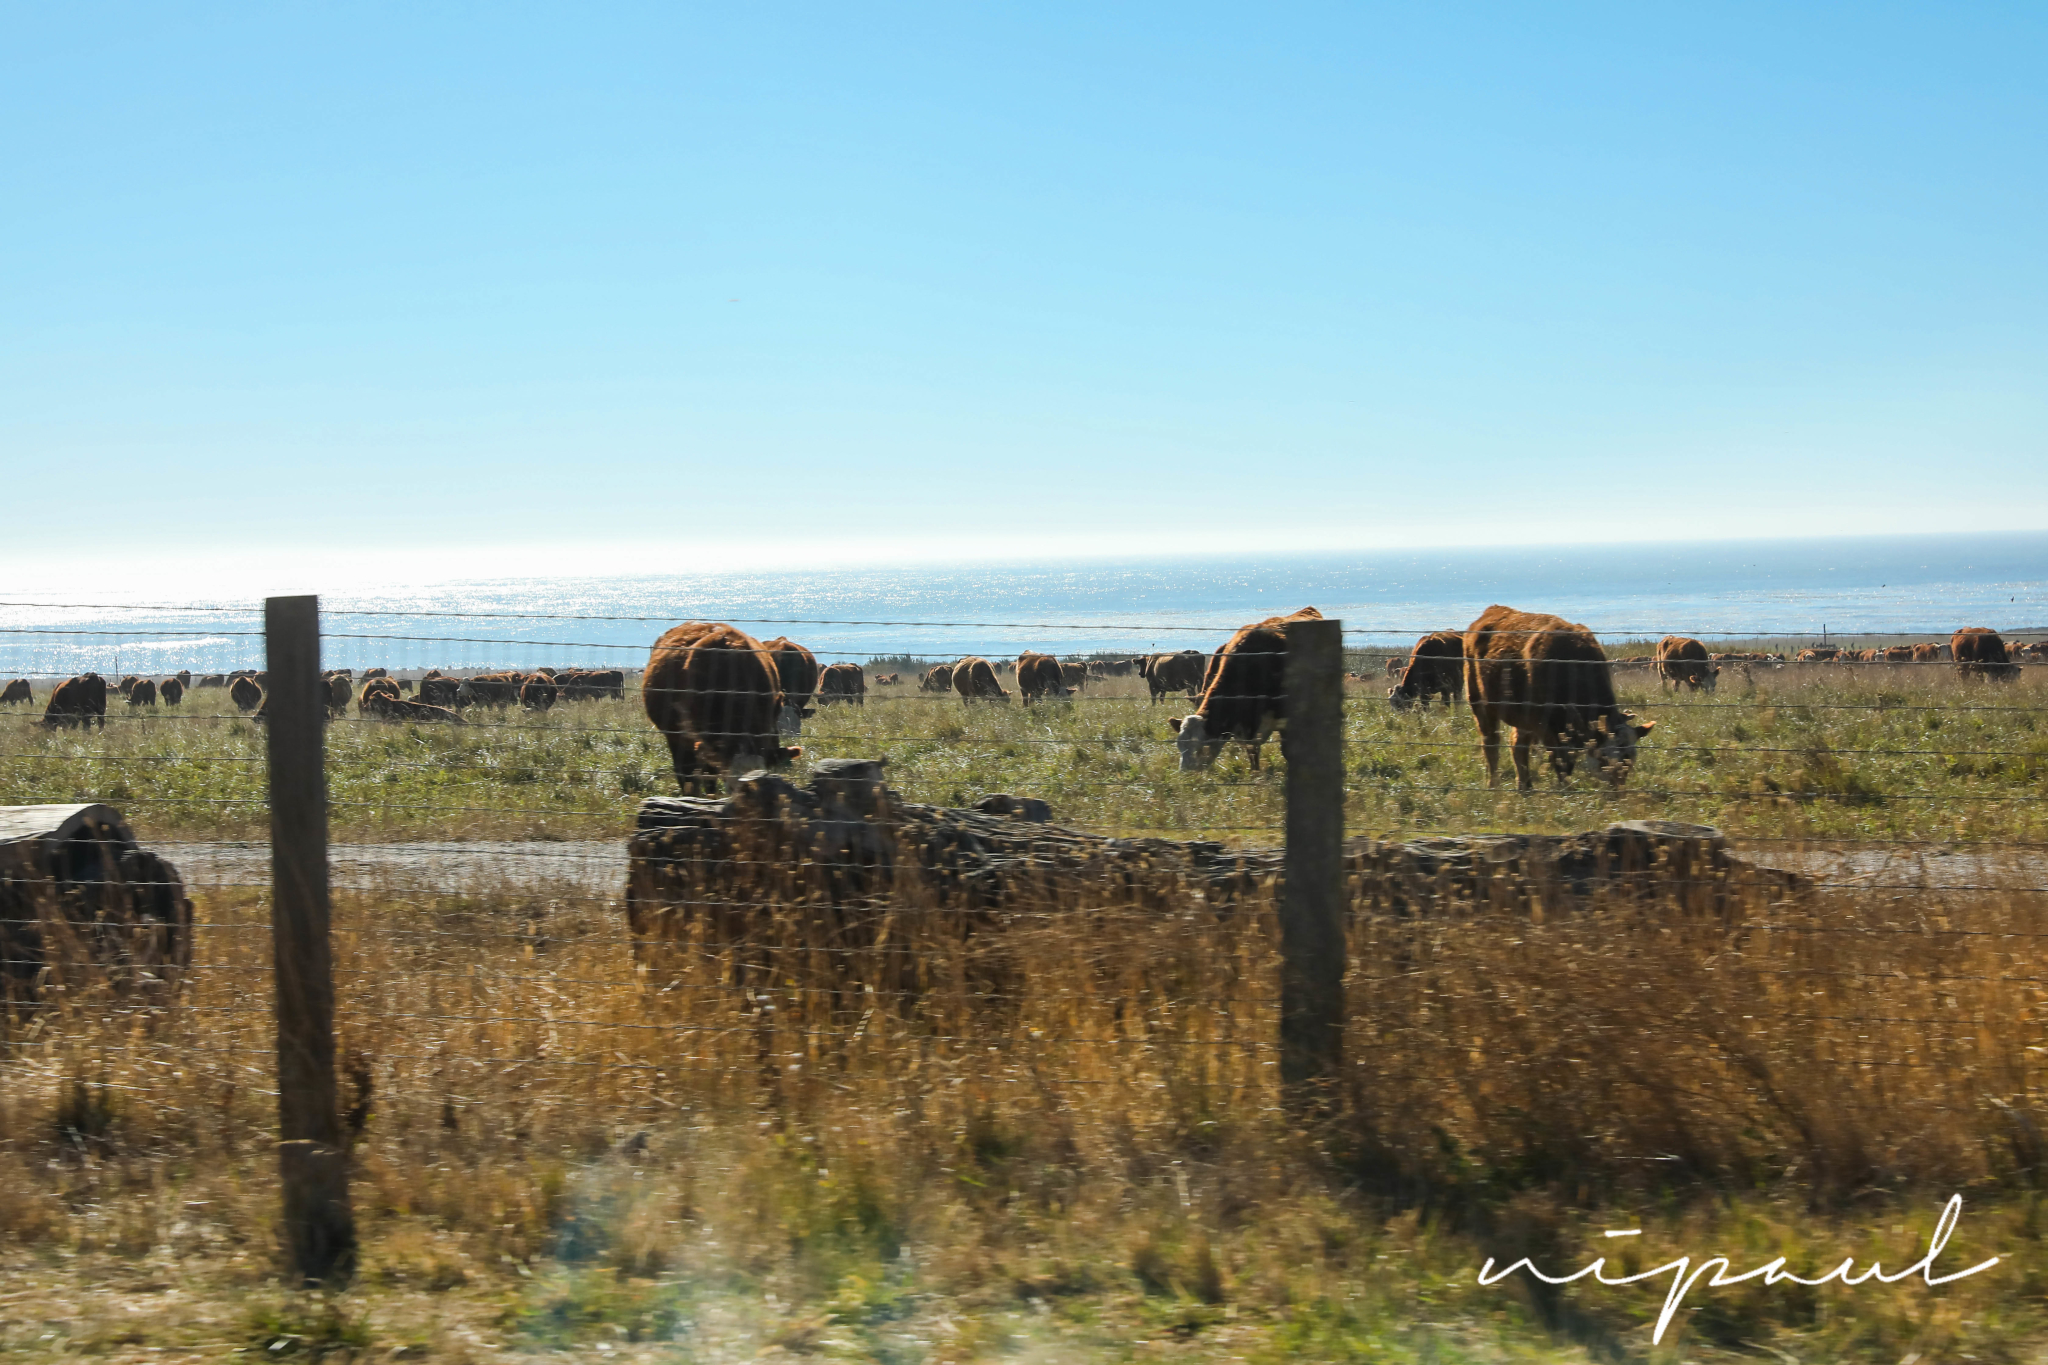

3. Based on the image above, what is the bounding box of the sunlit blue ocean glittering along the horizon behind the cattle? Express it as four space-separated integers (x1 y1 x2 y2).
0 532 2048 677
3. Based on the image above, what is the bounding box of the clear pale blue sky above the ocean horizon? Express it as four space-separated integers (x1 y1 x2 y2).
0 4 2048 573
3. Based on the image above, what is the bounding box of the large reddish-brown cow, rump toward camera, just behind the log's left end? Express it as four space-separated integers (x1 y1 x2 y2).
641 620 803 794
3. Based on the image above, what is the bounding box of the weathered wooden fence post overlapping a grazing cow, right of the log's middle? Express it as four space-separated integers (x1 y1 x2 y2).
1280 620 1348 1113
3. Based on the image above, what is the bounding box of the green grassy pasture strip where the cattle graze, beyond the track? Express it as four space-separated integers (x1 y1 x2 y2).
0 665 2048 843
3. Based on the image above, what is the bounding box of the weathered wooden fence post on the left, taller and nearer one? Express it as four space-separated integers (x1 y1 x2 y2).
264 598 356 1283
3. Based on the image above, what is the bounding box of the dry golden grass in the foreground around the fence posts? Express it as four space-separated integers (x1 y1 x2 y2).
0 839 2048 1361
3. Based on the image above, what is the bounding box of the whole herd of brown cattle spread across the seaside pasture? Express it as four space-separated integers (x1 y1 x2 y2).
0 606 2048 794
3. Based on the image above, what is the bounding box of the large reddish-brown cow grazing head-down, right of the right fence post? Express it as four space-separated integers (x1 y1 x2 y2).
1464 606 1657 792
